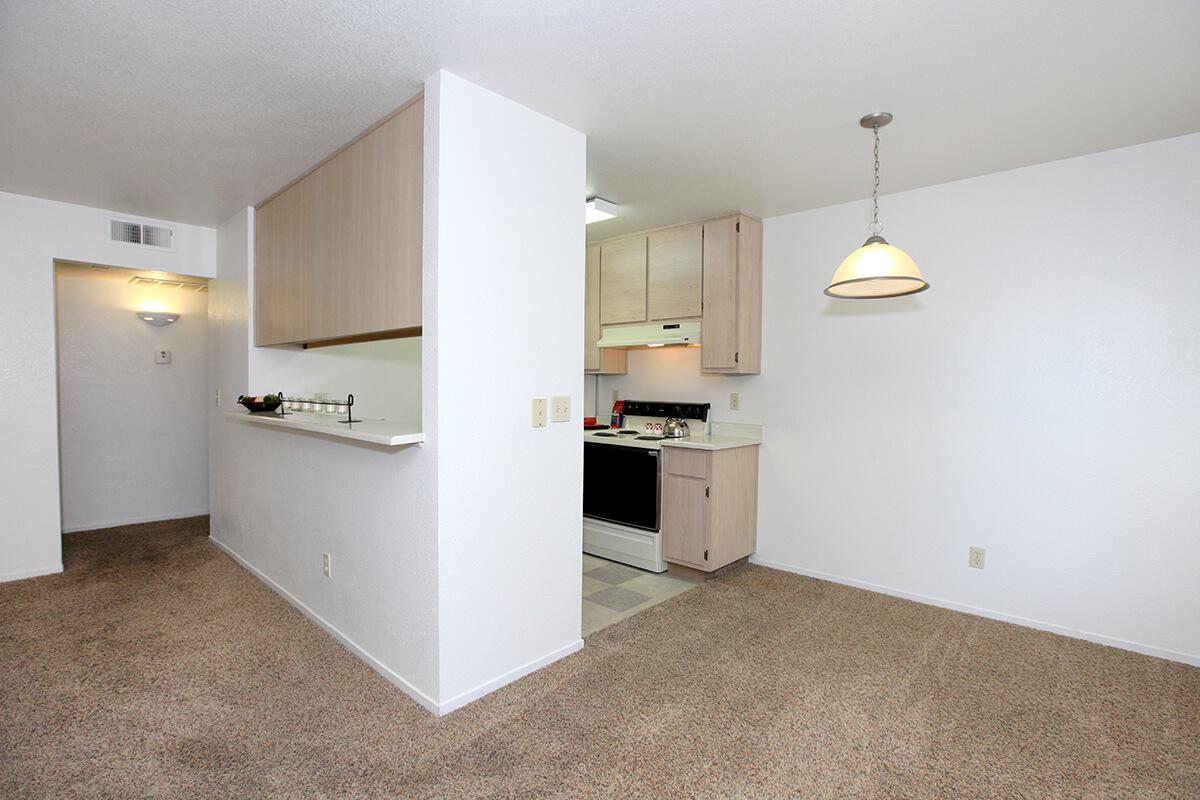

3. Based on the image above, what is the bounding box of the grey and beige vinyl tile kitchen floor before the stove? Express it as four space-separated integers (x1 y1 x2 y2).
583 553 698 636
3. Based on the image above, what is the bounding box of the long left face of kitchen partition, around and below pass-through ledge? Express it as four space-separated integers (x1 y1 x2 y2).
210 209 438 711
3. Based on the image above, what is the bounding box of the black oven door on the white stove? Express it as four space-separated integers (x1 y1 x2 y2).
583 441 662 530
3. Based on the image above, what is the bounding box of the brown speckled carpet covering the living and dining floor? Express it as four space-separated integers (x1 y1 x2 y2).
0 518 1200 800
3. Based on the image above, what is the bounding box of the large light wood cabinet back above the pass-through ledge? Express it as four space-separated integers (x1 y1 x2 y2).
254 98 425 345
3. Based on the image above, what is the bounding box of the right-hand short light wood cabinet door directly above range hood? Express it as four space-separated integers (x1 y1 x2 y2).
646 223 704 321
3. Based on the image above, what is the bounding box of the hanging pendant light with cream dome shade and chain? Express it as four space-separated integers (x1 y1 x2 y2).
826 112 929 300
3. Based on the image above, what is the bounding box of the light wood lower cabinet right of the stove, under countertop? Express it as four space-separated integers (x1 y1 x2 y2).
662 445 758 572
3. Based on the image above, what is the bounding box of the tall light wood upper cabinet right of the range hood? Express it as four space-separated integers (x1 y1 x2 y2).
700 215 762 374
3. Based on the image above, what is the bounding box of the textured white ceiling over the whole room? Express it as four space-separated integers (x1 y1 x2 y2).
0 0 1200 239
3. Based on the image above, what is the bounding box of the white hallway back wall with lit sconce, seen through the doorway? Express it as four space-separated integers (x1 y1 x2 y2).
58 266 209 531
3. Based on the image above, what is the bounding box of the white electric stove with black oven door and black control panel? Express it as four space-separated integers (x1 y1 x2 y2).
583 401 709 572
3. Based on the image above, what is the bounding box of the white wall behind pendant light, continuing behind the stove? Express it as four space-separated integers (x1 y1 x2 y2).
600 136 1200 663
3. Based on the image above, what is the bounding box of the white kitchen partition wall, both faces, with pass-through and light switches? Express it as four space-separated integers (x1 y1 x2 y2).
211 72 586 712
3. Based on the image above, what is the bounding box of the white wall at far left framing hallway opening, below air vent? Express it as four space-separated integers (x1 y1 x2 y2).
0 192 216 581
